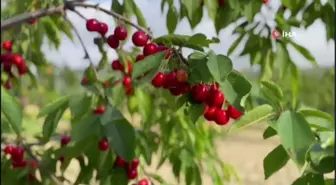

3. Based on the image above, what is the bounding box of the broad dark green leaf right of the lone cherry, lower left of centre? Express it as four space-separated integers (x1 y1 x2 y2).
104 119 135 162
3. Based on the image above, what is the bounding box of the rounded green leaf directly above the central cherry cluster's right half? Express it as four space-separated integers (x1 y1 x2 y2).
207 52 233 82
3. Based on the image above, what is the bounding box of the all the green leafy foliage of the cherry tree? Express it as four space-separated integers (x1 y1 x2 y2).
1 0 335 185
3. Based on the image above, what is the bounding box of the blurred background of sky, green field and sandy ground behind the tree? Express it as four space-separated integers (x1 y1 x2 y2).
1 0 335 185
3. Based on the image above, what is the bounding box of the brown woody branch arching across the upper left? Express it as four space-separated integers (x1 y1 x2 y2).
1 1 153 38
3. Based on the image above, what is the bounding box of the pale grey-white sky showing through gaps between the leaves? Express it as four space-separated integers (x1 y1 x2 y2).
42 0 335 70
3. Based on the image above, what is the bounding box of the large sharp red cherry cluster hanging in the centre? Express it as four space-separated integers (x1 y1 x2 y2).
152 69 242 125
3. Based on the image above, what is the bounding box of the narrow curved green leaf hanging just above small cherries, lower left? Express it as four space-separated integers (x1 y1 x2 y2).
42 104 68 142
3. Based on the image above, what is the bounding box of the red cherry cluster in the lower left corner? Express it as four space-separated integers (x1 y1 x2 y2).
3 145 37 181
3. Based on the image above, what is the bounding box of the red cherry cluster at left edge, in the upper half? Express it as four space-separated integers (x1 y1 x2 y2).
0 40 27 89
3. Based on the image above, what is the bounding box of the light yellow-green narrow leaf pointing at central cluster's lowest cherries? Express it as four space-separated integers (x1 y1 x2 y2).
229 105 274 132
